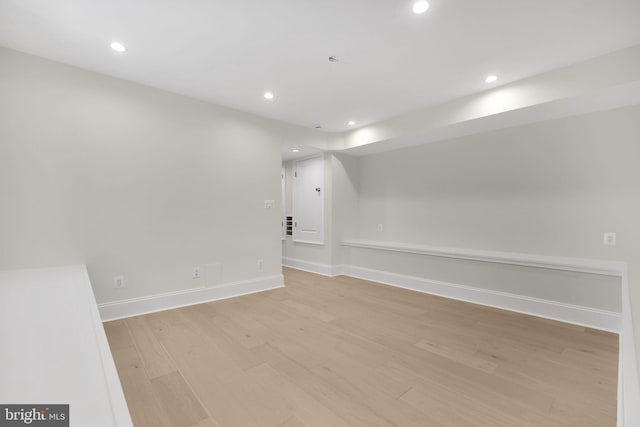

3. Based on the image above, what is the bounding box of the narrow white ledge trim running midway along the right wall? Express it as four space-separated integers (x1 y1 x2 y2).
342 240 626 277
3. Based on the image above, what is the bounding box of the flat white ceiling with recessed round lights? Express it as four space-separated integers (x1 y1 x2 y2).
0 0 640 131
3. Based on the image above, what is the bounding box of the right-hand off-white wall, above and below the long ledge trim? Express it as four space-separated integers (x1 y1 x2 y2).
351 107 640 311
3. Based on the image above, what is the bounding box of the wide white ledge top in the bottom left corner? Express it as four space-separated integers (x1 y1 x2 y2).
0 265 133 427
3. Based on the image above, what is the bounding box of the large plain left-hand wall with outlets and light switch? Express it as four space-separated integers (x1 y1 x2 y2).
0 49 317 302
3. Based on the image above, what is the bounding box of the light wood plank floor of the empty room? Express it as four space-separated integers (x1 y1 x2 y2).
105 269 618 427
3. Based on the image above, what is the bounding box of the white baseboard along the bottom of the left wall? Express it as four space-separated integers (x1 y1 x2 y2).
98 274 284 322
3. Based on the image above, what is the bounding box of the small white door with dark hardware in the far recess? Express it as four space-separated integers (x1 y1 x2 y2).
293 156 325 244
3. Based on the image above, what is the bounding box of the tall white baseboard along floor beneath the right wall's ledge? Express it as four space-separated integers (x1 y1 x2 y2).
345 265 621 333
